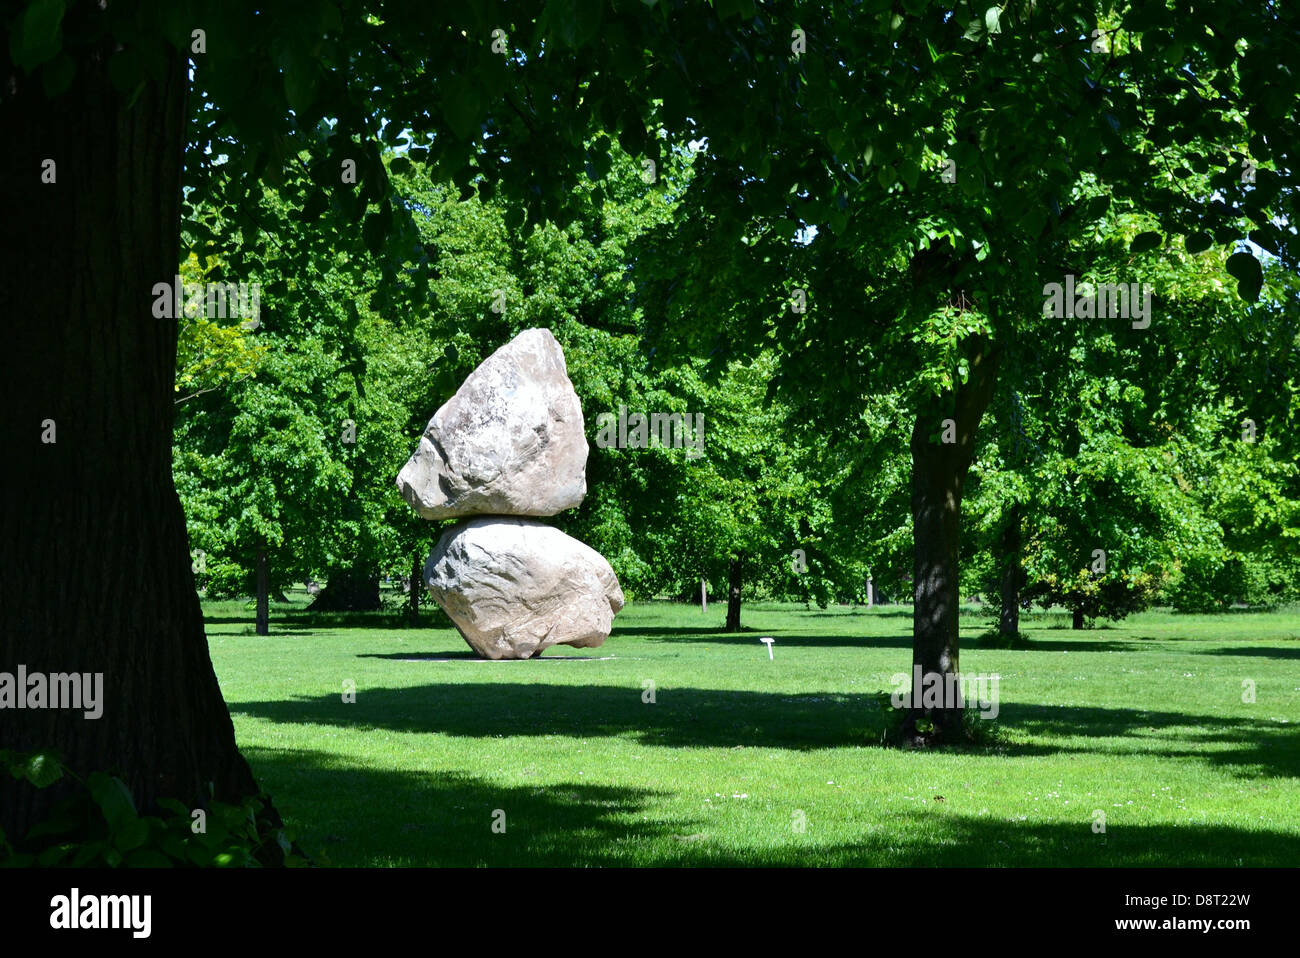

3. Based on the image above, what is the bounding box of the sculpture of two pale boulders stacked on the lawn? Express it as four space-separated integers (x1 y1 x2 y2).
397 329 623 659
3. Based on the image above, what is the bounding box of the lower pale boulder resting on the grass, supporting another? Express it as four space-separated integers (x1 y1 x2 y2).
424 517 623 659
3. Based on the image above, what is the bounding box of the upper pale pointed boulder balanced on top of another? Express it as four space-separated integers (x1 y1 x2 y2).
398 329 588 519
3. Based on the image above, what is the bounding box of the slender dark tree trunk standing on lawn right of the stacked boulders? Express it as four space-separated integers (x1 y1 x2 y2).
905 340 997 742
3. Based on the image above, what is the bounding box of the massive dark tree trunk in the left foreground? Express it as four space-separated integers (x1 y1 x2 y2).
0 33 269 840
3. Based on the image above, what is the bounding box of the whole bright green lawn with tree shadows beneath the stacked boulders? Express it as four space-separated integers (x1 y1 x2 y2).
205 590 1300 866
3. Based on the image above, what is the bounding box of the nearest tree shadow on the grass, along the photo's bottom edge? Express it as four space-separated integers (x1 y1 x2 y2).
246 749 1300 867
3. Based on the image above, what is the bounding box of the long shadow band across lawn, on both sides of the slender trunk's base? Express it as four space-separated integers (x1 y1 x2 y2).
230 681 1300 777
